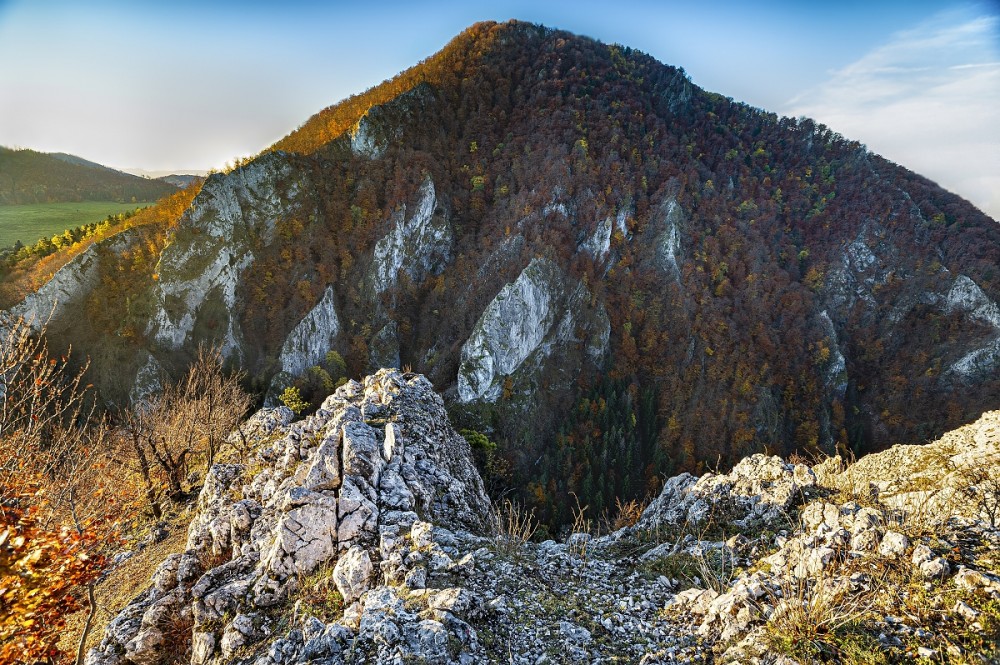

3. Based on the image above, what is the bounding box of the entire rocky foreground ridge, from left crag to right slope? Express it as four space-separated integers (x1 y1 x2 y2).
87 370 1000 665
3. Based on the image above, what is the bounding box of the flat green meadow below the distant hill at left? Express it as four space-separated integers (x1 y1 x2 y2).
0 201 150 249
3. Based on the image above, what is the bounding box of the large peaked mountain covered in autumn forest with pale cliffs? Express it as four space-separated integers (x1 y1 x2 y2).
1 22 1000 526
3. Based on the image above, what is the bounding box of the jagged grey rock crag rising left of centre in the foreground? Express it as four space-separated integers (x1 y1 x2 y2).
87 370 492 665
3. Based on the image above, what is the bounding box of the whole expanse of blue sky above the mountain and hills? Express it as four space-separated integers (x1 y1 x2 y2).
0 0 1000 218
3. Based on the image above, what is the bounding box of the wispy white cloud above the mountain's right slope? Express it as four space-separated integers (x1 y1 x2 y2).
782 9 1000 219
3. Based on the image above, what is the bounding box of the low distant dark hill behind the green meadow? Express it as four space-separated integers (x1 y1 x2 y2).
0 147 177 205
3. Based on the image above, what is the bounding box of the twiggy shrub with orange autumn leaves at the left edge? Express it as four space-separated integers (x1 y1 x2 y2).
0 314 133 663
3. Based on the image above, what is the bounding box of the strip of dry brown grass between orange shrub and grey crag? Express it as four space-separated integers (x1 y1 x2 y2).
59 515 190 653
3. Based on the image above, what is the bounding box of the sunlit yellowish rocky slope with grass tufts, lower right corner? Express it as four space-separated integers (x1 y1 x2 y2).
664 411 1000 663
